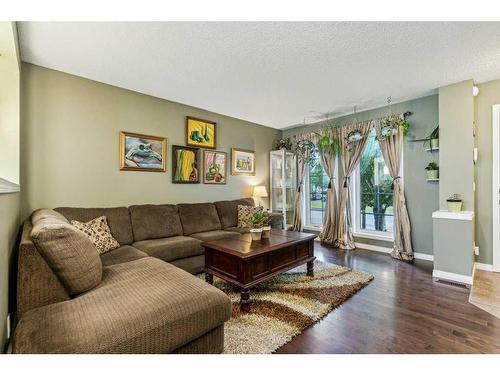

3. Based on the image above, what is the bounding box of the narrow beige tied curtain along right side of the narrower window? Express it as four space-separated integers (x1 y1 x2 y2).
319 140 338 245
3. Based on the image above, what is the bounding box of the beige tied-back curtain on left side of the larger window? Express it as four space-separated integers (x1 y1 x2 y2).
335 121 373 250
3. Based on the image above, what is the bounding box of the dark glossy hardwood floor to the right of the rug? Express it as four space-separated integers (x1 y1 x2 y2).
277 243 500 353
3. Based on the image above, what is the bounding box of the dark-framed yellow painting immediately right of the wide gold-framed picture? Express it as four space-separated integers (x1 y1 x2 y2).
172 146 200 184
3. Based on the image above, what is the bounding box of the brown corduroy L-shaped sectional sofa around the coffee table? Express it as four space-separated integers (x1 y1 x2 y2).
13 198 282 353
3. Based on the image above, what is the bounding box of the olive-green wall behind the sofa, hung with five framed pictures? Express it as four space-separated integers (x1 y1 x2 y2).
21 64 280 217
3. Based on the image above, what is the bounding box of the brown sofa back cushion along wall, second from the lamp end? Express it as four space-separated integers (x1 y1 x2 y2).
177 203 221 236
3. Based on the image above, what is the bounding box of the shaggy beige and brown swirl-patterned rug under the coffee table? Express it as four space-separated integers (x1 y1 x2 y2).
203 261 373 354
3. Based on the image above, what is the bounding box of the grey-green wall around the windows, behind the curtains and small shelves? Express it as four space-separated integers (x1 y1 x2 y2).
283 95 439 254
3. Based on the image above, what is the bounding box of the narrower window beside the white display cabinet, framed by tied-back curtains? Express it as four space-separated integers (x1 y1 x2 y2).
304 155 334 228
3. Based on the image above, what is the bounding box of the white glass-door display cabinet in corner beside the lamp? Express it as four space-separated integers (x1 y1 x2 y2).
269 150 297 228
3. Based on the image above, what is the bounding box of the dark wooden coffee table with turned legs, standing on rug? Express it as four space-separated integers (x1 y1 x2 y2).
202 229 316 304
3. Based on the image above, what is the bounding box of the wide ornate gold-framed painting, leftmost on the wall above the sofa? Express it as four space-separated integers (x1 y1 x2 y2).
120 131 167 172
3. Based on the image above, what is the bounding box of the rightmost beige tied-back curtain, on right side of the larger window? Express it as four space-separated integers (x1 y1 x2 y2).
375 122 413 262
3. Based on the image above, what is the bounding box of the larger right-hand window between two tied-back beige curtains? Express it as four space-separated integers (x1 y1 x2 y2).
351 131 394 238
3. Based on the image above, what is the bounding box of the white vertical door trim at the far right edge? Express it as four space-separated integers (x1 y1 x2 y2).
491 104 500 272
